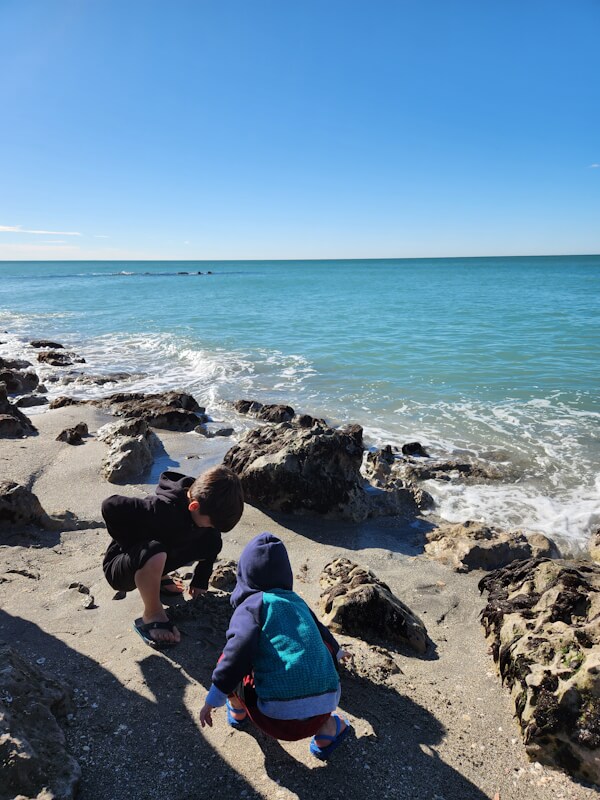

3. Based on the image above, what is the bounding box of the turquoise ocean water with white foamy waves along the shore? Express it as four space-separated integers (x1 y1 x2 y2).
0 256 600 547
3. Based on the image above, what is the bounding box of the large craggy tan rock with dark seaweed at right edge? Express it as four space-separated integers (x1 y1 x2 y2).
479 558 600 784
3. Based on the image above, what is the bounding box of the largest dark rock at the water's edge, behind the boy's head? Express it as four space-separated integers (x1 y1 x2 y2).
223 423 369 520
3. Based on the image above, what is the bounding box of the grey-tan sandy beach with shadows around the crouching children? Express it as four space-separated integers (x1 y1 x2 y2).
0 406 597 800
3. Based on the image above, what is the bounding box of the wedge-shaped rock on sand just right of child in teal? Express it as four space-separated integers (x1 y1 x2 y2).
319 558 429 654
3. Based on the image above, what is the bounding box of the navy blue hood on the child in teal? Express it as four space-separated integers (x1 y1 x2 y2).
231 533 294 608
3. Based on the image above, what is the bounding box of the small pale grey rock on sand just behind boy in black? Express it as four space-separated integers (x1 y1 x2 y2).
98 418 160 483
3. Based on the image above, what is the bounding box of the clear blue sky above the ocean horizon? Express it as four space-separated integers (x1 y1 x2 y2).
0 0 600 259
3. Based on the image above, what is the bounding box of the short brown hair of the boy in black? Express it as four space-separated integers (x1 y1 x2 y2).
189 466 244 533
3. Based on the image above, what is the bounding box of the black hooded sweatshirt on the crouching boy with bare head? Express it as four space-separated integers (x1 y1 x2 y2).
102 472 223 589
